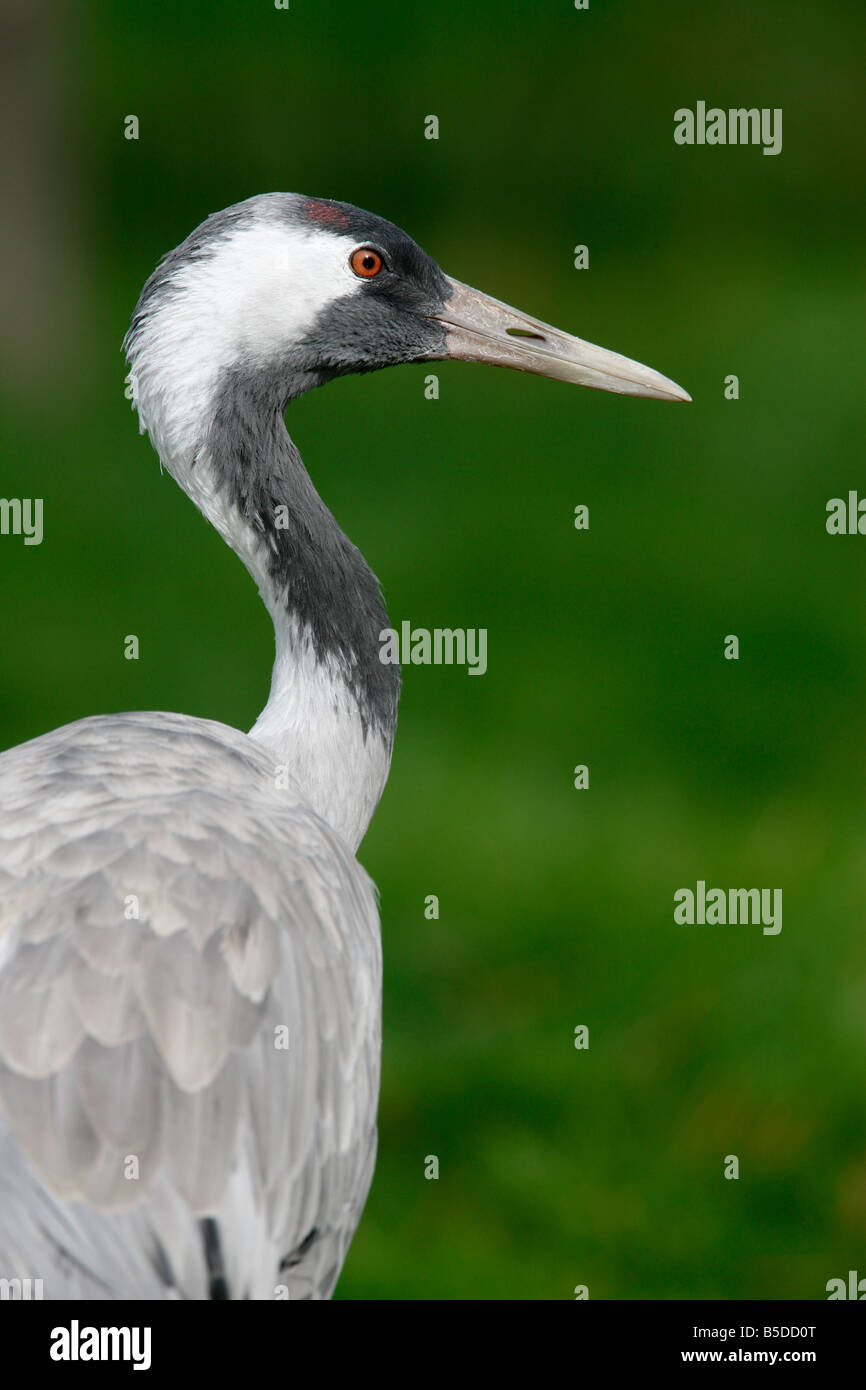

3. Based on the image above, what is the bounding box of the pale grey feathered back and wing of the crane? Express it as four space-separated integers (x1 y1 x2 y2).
0 714 381 1297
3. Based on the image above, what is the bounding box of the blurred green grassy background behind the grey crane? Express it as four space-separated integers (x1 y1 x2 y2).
0 0 866 1298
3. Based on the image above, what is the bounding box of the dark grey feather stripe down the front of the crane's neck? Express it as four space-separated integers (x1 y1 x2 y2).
207 368 400 746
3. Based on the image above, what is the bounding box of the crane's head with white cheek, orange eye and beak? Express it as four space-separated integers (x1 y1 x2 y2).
124 193 691 428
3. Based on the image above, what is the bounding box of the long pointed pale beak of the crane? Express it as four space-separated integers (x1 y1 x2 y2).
436 275 692 400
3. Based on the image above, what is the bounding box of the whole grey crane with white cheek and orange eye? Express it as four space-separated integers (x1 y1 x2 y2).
0 193 689 1300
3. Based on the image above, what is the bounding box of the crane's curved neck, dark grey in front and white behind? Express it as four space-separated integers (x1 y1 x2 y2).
180 374 400 849
